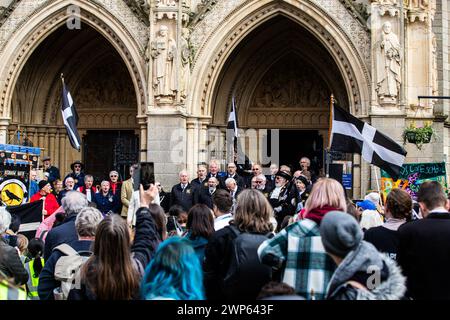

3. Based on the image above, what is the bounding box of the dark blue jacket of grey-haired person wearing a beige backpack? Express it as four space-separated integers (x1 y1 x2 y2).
38 240 93 300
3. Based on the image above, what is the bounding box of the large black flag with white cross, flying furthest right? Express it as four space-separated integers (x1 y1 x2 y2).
330 105 406 179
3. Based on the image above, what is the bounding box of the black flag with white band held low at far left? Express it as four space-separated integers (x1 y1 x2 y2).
6 200 44 239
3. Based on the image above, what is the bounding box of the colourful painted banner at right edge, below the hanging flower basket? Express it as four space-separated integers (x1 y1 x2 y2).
381 162 447 200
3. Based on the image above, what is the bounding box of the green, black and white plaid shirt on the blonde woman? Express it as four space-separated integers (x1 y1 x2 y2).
258 219 336 300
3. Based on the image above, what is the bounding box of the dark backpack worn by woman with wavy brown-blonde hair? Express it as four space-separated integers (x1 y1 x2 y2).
223 225 273 299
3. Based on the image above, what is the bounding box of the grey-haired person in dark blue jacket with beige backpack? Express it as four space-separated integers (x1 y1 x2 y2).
38 207 103 300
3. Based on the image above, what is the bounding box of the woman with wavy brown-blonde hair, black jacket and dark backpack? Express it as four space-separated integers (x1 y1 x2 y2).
203 189 274 301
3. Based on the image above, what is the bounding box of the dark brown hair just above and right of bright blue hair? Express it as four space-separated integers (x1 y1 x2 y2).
186 204 214 239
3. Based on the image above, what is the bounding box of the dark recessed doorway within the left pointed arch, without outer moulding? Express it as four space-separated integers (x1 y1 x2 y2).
8 23 139 180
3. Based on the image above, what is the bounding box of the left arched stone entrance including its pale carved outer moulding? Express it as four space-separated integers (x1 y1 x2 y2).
0 1 147 180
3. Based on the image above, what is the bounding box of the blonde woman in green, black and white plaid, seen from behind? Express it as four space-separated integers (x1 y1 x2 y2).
258 178 347 299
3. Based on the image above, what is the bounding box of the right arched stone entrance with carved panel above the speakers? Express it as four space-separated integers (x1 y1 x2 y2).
187 1 370 198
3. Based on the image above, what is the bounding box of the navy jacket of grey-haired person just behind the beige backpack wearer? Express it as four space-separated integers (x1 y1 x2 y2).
44 214 78 261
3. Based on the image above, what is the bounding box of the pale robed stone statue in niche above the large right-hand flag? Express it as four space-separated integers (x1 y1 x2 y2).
376 22 401 103
